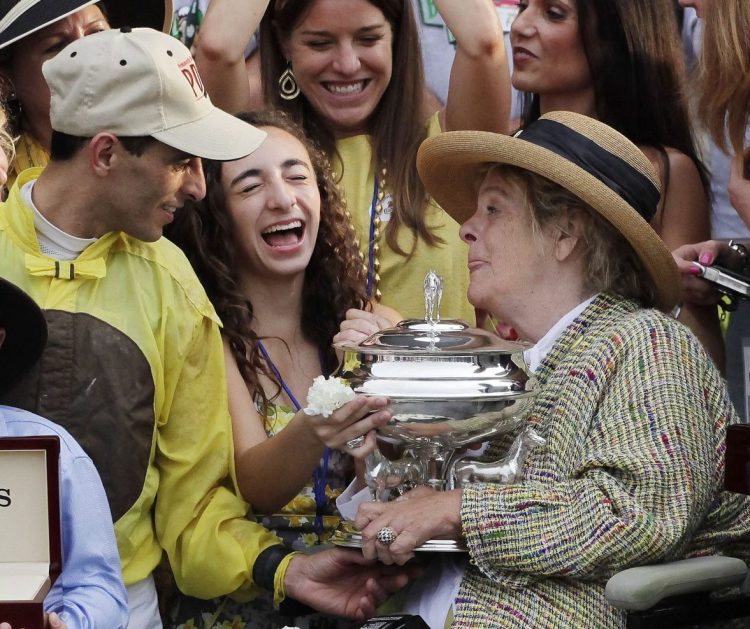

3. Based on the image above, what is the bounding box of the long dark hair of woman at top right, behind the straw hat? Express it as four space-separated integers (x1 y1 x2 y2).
523 0 710 190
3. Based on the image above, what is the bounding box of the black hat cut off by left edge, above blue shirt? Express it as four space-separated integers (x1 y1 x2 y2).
0 278 47 391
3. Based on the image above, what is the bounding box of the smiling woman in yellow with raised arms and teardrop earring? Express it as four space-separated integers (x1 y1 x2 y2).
191 0 510 322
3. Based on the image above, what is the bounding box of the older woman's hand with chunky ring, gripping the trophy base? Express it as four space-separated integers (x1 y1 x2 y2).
354 487 462 565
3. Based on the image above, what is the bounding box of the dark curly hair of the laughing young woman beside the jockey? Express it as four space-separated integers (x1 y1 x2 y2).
165 111 367 405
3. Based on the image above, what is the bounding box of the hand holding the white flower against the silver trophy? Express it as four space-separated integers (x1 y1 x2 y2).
307 395 392 458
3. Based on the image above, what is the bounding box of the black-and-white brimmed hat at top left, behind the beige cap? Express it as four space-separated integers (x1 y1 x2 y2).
0 0 172 49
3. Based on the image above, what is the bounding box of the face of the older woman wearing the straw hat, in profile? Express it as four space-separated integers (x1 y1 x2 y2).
460 168 554 323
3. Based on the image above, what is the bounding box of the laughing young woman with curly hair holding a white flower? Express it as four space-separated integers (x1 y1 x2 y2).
168 112 395 628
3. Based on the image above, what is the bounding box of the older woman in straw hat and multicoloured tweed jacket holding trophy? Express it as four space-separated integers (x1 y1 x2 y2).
341 112 750 629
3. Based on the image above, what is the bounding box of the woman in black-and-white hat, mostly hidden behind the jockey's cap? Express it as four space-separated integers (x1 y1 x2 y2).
0 0 172 187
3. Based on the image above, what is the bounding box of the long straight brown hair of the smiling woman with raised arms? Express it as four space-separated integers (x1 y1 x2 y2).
260 0 440 254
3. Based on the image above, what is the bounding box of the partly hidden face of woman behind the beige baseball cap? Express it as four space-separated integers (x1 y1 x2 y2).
2 5 108 148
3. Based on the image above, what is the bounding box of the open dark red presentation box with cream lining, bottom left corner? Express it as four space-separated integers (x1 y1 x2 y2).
0 436 62 629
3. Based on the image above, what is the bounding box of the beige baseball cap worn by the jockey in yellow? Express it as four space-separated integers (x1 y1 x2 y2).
42 28 266 160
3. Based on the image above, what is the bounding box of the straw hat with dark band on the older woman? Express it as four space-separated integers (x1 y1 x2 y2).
417 111 680 311
